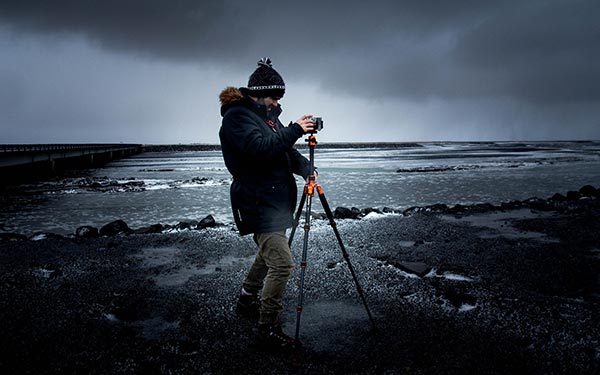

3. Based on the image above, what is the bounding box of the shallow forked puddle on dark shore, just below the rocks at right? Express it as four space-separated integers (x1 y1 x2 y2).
440 209 560 242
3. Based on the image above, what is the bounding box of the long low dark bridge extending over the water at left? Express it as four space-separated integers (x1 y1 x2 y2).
0 143 144 185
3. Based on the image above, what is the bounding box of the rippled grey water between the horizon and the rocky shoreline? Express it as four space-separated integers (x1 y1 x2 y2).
0 142 600 235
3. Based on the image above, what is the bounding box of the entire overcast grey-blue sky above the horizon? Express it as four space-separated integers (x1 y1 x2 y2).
0 0 600 144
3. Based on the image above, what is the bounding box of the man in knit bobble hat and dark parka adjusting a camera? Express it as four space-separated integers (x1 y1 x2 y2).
219 58 314 348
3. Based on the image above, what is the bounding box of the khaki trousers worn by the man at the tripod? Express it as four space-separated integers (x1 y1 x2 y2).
244 231 294 323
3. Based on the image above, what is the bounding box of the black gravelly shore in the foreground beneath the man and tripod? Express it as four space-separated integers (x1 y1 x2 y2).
0 191 600 374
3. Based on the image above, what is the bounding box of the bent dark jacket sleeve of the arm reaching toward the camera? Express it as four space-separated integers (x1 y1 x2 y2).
222 111 304 159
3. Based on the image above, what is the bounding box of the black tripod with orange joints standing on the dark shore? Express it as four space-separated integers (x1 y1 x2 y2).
288 133 376 342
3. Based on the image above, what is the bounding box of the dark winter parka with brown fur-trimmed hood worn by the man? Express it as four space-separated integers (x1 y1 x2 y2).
219 87 310 235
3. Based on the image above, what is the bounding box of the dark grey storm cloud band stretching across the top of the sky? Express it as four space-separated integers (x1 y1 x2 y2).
0 0 600 104
